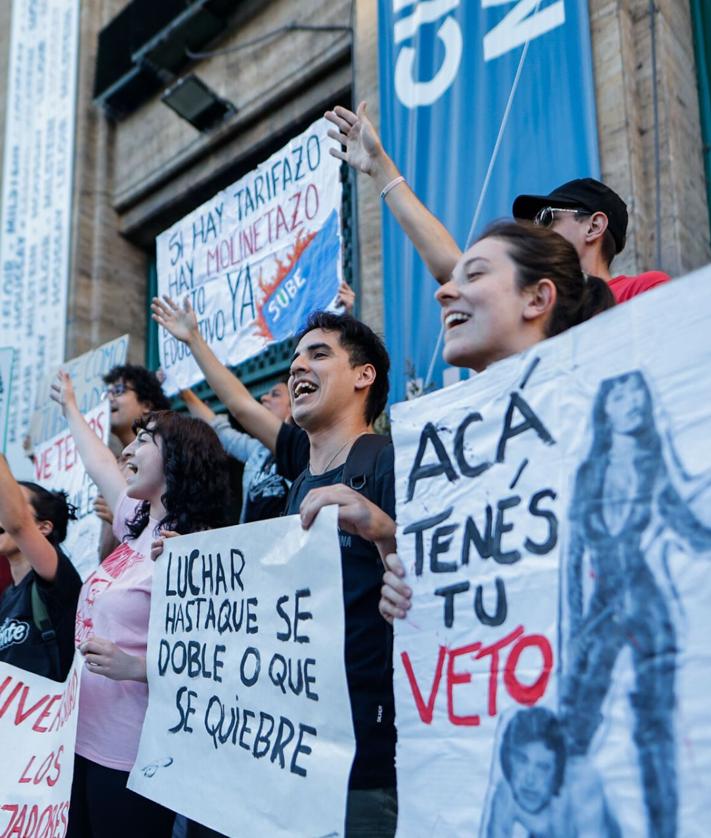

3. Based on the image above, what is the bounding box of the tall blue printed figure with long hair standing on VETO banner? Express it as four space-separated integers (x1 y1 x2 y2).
560 371 711 837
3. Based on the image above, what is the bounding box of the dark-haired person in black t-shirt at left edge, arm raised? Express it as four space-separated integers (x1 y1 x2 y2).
0 454 81 681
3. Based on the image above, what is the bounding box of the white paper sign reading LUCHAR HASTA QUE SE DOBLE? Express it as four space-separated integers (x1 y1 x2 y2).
129 507 355 838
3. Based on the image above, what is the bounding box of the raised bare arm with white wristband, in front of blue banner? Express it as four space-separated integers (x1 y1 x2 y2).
325 102 462 284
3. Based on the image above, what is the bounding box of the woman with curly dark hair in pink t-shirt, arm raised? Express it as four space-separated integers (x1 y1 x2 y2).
52 373 229 838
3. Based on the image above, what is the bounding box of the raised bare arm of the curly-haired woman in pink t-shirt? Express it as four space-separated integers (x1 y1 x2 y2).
51 370 126 512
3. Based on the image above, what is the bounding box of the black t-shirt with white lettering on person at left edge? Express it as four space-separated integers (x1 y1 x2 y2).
0 550 81 681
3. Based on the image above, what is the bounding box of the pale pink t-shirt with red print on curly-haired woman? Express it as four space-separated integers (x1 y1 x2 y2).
76 493 158 771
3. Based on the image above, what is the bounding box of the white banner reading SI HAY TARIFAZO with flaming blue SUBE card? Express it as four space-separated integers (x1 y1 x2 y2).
156 119 342 394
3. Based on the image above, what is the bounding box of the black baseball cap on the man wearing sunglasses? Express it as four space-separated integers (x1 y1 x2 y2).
512 177 627 253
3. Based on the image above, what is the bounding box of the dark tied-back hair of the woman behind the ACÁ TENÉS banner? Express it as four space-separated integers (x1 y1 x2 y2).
478 221 615 337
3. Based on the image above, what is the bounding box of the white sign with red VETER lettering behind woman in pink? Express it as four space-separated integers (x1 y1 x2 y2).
35 401 110 579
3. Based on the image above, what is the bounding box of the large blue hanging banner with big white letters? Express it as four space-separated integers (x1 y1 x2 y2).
379 0 599 399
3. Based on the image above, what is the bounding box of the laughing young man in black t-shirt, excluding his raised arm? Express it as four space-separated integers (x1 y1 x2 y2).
277 312 397 838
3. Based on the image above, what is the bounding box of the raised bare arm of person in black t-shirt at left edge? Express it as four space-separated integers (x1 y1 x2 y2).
0 454 58 582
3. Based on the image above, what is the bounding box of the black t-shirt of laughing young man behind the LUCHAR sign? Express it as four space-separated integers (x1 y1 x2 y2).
286 445 395 789
